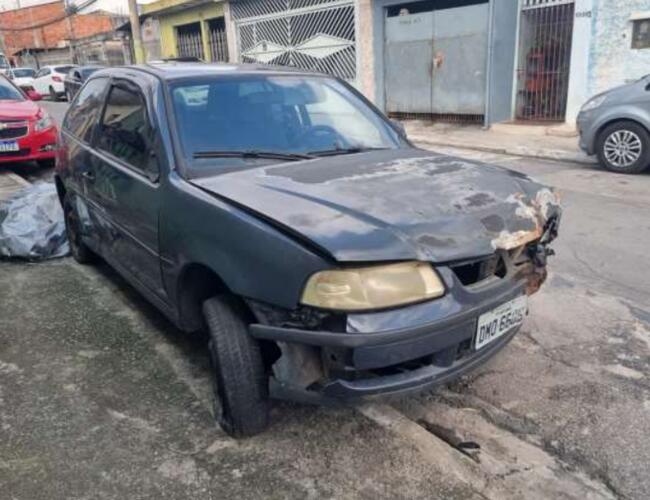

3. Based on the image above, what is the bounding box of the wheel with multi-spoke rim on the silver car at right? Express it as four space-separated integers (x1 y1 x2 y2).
596 121 650 174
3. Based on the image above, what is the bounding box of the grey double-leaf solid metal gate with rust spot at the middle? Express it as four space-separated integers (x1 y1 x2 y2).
385 3 489 118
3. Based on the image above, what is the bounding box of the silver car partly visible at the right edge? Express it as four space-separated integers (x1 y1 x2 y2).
578 75 650 174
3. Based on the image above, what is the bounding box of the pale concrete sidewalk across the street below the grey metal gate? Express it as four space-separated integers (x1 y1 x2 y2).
404 120 596 164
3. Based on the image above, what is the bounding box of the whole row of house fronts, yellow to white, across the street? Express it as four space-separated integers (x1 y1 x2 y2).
129 0 650 125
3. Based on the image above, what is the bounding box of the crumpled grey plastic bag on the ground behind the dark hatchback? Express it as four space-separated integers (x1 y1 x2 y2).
0 182 70 260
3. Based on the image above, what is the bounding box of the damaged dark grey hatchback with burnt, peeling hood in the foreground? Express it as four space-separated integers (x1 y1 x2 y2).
56 64 561 436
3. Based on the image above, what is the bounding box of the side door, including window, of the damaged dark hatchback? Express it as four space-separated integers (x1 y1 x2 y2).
88 79 165 299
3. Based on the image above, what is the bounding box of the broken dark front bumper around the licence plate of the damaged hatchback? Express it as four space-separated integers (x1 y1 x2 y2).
250 283 526 400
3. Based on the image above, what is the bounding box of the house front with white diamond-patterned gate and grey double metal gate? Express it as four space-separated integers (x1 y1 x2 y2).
226 0 518 123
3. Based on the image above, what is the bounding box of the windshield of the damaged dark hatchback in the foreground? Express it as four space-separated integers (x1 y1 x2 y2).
171 75 401 174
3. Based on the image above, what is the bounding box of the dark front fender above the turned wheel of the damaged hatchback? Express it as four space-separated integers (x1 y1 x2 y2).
160 173 334 308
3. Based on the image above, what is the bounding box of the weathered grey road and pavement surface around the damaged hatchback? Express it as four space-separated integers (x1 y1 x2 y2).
0 103 650 499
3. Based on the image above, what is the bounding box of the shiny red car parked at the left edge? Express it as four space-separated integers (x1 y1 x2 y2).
0 76 58 166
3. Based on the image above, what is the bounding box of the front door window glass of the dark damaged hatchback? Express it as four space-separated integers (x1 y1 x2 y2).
97 85 157 175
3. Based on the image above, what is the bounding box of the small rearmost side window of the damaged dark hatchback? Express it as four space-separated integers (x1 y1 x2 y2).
63 78 108 142
